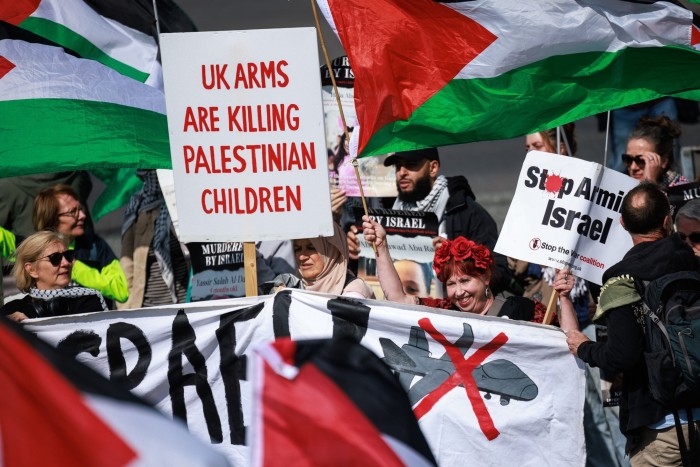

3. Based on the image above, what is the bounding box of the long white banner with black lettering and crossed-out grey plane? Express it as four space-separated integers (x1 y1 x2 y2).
25 290 585 467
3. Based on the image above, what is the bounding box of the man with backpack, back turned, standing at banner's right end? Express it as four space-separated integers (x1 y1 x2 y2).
567 182 700 466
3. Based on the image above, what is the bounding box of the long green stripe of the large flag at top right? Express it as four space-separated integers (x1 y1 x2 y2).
362 47 700 157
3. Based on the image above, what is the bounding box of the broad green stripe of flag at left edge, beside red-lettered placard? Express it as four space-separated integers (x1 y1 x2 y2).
0 99 172 177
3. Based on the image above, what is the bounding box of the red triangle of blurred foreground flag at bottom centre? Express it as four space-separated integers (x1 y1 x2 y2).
261 362 403 467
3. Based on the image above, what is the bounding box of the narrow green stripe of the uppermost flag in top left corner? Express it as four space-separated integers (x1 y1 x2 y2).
19 17 148 83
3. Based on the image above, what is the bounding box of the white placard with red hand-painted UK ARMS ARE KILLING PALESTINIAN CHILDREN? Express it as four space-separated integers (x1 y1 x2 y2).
160 28 333 242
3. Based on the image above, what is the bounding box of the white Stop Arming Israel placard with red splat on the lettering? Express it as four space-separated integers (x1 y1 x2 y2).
495 151 639 284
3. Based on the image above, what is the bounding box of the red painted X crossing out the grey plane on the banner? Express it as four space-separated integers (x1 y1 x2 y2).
413 318 508 440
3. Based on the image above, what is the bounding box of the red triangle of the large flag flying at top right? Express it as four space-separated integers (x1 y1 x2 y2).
328 0 497 152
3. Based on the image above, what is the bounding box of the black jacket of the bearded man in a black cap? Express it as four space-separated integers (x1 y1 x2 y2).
444 175 522 294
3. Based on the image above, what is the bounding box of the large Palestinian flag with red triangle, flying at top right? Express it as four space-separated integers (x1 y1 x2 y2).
317 0 700 156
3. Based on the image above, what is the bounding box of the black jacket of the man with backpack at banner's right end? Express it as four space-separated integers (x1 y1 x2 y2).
578 234 699 452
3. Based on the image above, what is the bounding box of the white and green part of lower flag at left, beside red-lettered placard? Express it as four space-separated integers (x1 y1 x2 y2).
0 35 171 176
